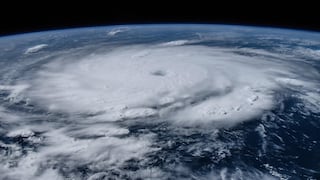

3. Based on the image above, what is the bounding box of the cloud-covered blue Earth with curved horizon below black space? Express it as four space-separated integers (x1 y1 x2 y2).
0 24 320 180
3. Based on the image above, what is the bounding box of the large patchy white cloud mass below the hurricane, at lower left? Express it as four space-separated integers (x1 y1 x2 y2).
0 124 158 180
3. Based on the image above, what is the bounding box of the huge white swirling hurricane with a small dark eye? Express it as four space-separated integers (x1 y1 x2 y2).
23 46 308 126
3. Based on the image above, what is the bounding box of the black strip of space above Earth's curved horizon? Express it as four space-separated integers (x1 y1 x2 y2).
0 1 320 35
